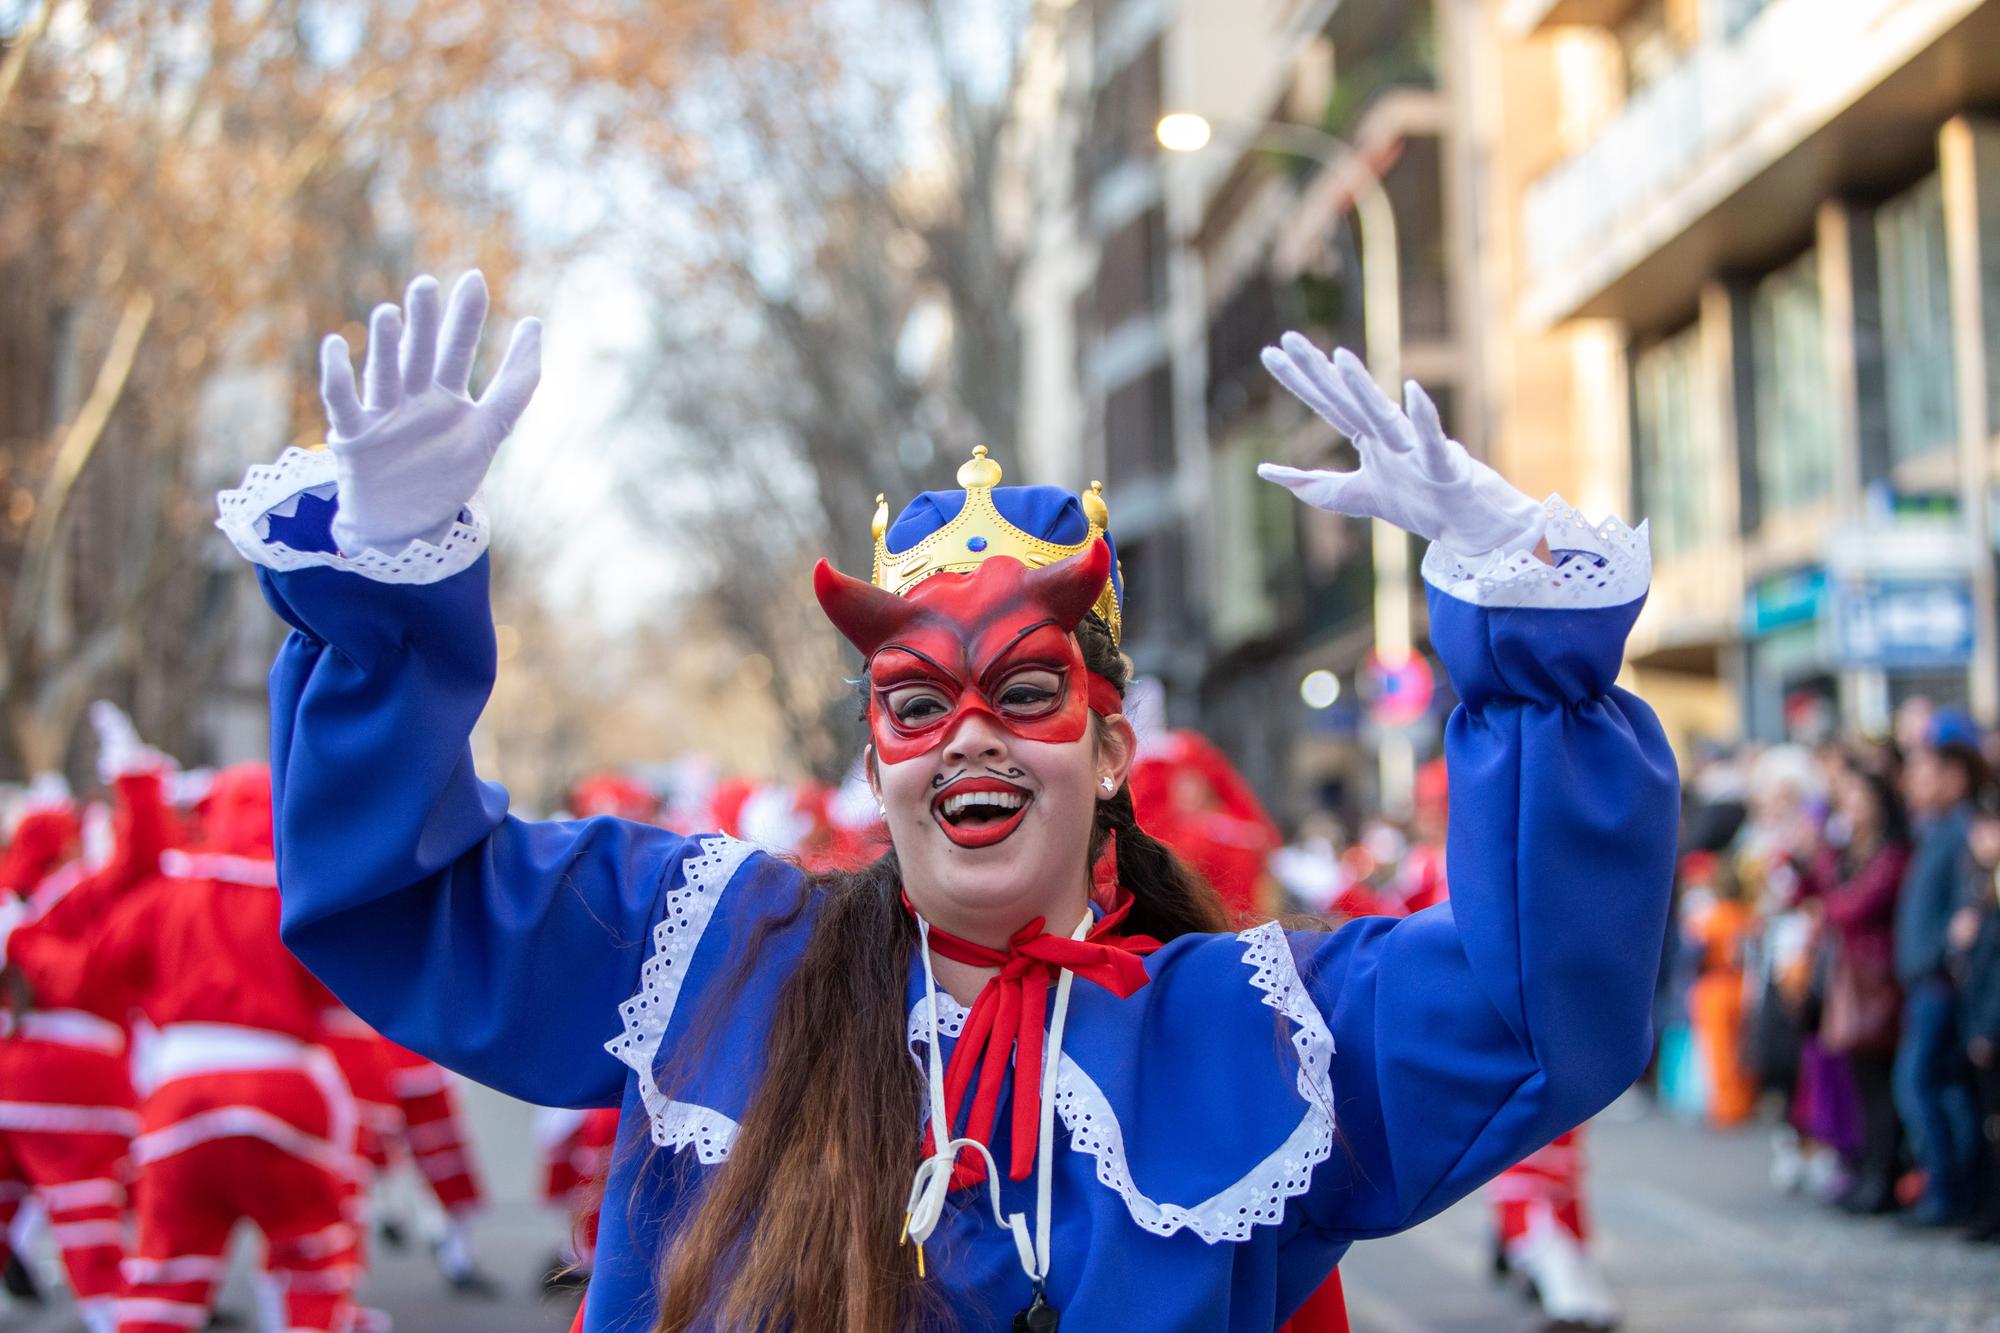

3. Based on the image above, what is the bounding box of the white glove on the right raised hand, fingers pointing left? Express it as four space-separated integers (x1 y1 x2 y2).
1256 332 1548 556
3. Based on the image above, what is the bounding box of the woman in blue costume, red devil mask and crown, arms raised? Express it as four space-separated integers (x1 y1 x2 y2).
220 274 1676 1333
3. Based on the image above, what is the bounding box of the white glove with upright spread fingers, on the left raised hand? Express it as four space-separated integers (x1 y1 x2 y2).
320 268 542 554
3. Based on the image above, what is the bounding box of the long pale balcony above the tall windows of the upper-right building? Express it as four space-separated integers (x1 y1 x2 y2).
1522 0 2000 328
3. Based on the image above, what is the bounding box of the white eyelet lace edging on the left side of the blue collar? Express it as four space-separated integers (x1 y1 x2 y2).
604 835 756 1165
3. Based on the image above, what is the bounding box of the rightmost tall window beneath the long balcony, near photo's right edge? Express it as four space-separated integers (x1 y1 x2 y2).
1876 174 1958 462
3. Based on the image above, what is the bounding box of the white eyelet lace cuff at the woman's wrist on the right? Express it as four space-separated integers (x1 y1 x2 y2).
1424 494 1652 610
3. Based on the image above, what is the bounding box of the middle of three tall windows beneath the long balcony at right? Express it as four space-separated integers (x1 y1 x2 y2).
1750 250 1836 514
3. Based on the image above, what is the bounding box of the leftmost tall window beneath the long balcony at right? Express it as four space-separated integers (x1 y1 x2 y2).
1632 326 1730 556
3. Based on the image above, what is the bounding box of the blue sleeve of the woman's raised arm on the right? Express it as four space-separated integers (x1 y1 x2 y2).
1292 588 1678 1239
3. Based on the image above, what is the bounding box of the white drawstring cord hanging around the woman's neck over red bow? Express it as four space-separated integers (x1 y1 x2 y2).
904 911 1094 1291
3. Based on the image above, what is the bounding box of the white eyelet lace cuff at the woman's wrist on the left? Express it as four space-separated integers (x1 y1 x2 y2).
216 448 490 582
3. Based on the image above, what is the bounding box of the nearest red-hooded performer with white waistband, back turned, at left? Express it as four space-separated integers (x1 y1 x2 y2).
10 765 356 1333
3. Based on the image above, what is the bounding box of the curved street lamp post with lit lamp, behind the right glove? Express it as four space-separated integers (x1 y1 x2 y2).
1154 112 1416 815
